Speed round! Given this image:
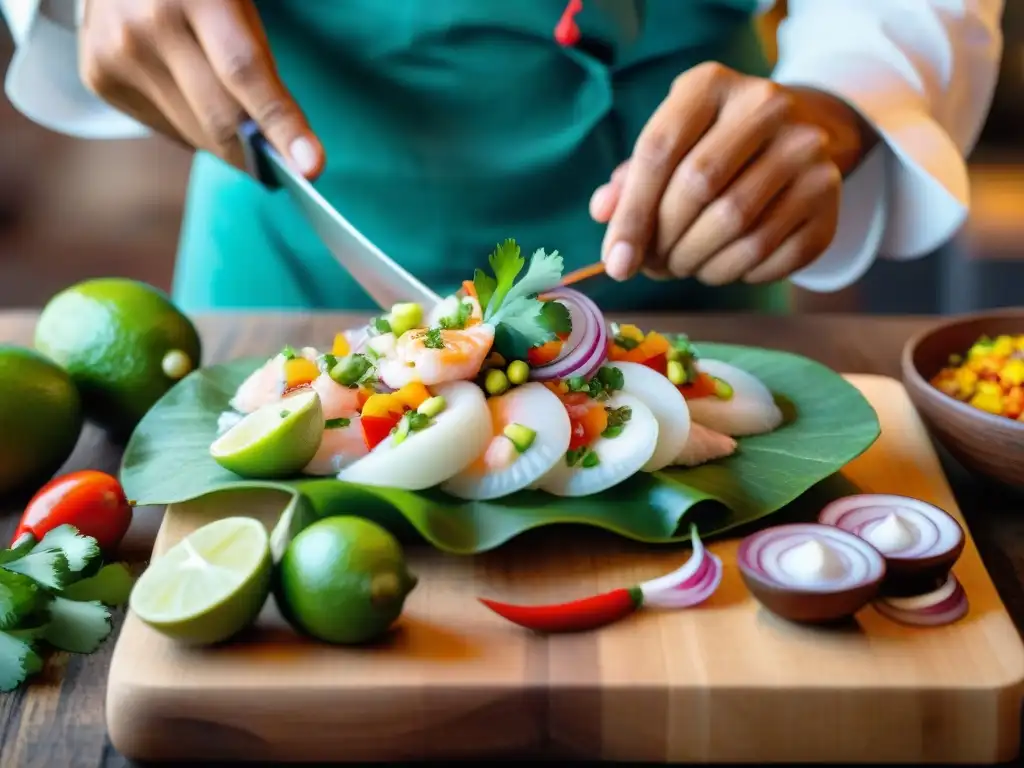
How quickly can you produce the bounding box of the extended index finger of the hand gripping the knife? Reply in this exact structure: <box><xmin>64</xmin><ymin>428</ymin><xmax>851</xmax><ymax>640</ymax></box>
<box><xmin>188</xmin><ymin>0</ymin><xmax>325</xmax><ymax>177</ymax></box>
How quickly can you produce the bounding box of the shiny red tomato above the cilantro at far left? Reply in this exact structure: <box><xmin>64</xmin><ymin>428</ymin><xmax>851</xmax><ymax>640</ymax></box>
<box><xmin>11</xmin><ymin>470</ymin><xmax>132</xmax><ymax>555</ymax></box>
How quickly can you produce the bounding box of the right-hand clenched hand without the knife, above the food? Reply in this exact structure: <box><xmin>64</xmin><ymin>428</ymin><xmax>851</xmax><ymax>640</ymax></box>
<box><xmin>591</xmin><ymin>63</ymin><xmax>874</xmax><ymax>286</ymax></box>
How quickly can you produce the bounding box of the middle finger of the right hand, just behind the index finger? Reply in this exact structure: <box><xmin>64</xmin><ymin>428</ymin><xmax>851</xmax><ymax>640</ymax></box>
<box><xmin>654</xmin><ymin>80</ymin><xmax>792</xmax><ymax>278</ymax></box>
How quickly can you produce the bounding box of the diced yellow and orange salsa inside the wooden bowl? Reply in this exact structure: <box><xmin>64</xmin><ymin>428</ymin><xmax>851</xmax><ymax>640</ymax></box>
<box><xmin>932</xmin><ymin>334</ymin><xmax>1024</xmax><ymax>422</ymax></box>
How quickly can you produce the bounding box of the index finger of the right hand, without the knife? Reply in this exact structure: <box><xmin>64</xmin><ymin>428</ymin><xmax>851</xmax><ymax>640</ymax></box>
<box><xmin>601</xmin><ymin>65</ymin><xmax>724</xmax><ymax>280</ymax></box>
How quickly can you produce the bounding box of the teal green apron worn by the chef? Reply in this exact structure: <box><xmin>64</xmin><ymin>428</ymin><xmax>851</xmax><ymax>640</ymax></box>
<box><xmin>174</xmin><ymin>0</ymin><xmax>787</xmax><ymax>312</ymax></box>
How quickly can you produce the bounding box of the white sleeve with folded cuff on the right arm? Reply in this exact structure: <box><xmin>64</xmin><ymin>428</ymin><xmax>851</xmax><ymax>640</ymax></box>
<box><xmin>761</xmin><ymin>0</ymin><xmax>1004</xmax><ymax>292</ymax></box>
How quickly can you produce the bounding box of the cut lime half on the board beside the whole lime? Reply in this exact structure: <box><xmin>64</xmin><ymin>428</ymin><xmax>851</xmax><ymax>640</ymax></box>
<box><xmin>129</xmin><ymin>517</ymin><xmax>272</xmax><ymax>645</ymax></box>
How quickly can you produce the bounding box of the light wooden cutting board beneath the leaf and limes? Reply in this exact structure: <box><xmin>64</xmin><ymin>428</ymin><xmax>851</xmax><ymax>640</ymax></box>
<box><xmin>106</xmin><ymin>376</ymin><xmax>1024</xmax><ymax>764</ymax></box>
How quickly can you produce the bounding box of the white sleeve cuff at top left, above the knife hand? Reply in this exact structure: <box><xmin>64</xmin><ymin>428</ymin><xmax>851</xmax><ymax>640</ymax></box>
<box><xmin>0</xmin><ymin>0</ymin><xmax>150</xmax><ymax>138</ymax></box>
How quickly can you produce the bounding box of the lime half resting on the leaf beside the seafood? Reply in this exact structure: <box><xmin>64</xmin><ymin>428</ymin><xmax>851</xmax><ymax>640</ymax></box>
<box><xmin>210</xmin><ymin>389</ymin><xmax>324</xmax><ymax>478</ymax></box>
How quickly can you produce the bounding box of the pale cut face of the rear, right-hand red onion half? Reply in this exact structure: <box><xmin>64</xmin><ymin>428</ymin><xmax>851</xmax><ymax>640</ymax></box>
<box><xmin>818</xmin><ymin>494</ymin><xmax>964</xmax><ymax>564</ymax></box>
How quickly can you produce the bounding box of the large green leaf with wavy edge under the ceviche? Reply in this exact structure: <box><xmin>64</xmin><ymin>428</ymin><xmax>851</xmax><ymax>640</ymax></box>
<box><xmin>121</xmin><ymin>343</ymin><xmax>880</xmax><ymax>554</ymax></box>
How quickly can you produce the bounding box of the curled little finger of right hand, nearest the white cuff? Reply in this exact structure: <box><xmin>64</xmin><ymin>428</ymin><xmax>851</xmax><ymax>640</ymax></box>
<box><xmin>696</xmin><ymin>162</ymin><xmax>842</xmax><ymax>285</ymax></box>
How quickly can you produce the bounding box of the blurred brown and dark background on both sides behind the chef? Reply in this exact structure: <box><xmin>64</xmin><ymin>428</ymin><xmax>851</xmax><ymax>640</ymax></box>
<box><xmin>0</xmin><ymin>5</ymin><xmax>1024</xmax><ymax>313</ymax></box>
